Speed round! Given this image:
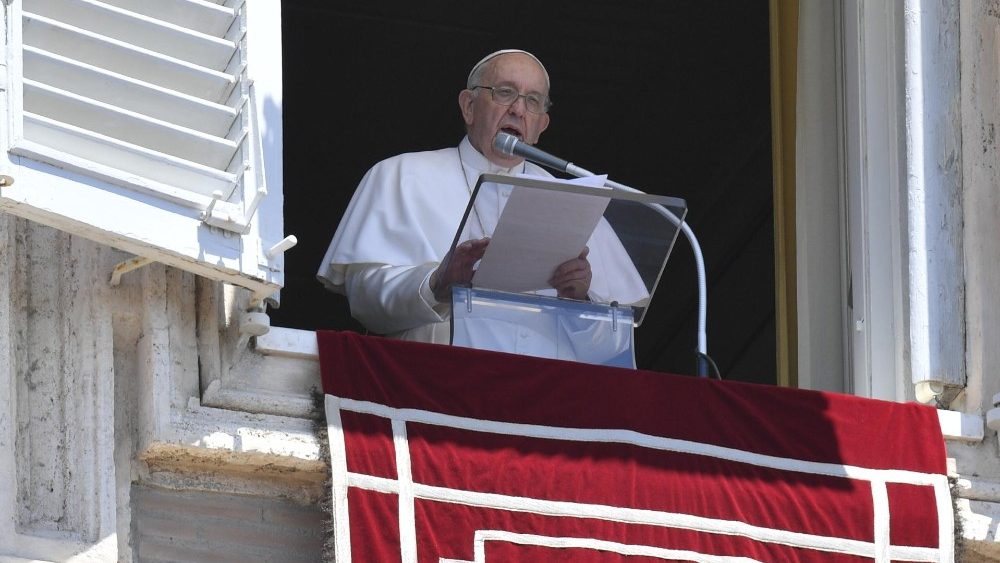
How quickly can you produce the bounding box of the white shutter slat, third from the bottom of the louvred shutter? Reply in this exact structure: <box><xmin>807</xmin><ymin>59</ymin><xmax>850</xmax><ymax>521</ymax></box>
<box><xmin>24</xmin><ymin>46</ymin><xmax>238</xmax><ymax>137</ymax></box>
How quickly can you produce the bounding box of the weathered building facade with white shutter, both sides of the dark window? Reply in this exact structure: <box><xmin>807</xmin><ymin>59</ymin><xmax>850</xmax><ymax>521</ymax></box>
<box><xmin>0</xmin><ymin>0</ymin><xmax>1000</xmax><ymax>561</ymax></box>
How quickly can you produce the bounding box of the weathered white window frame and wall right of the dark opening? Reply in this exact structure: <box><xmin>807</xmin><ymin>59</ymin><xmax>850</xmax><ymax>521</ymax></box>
<box><xmin>797</xmin><ymin>0</ymin><xmax>1000</xmax><ymax>561</ymax></box>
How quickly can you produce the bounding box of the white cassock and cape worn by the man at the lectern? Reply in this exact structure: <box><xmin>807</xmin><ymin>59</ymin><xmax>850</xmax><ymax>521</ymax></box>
<box><xmin>317</xmin><ymin>138</ymin><xmax>648</xmax><ymax>354</ymax></box>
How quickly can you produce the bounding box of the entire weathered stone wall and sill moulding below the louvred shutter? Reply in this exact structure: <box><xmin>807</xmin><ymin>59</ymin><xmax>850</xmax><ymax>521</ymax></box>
<box><xmin>0</xmin><ymin>214</ymin><xmax>326</xmax><ymax>561</ymax></box>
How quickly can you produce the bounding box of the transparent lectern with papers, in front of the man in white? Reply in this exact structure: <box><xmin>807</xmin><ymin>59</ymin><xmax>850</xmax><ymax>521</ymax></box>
<box><xmin>442</xmin><ymin>174</ymin><xmax>687</xmax><ymax>368</ymax></box>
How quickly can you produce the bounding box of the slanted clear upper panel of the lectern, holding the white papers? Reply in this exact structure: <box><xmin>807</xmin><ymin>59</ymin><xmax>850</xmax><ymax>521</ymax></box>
<box><xmin>451</xmin><ymin>174</ymin><xmax>687</xmax><ymax>326</ymax></box>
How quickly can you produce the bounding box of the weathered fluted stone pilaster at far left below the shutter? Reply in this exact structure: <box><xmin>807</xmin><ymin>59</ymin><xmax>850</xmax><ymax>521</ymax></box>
<box><xmin>0</xmin><ymin>215</ymin><xmax>115</xmax><ymax>559</ymax></box>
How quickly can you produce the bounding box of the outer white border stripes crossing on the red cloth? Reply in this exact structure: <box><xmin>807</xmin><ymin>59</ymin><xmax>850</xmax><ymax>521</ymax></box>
<box><xmin>327</xmin><ymin>396</ymin><xmax>954</xmax><ymax>563</ymax></box>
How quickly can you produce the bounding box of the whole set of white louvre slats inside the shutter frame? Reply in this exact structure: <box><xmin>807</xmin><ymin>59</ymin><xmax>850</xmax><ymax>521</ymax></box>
<box><xmin>19</xmin><ymin>0</ymin><xmax>258</xmax><ymax>212</ymax></box>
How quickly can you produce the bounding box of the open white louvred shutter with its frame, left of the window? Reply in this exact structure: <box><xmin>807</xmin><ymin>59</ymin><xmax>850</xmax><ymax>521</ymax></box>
<box><xmin>0</xmin><ymin>0</ymin><xmax>283</xmax><ymax>295</ymax></box>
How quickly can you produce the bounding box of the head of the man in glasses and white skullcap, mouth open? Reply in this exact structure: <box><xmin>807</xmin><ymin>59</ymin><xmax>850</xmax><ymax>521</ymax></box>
<box><xmin>458</xmin><ymin>53</ymin><xmax>549</xmax><ymax>167</ymax></box>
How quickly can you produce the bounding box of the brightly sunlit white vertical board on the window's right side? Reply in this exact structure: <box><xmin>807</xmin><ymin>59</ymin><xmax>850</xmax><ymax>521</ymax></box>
<box><xmin>903</xmin><ymin>0</ymin><xmax>964</xmax><ymax>402</ymax></box>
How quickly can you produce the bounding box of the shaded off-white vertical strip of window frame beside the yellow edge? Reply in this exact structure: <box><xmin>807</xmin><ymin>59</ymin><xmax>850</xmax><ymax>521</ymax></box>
<box><xmin>795</xmin><ymin>0</ymin><xmax>849</xmax><ymax>392</ymax></box>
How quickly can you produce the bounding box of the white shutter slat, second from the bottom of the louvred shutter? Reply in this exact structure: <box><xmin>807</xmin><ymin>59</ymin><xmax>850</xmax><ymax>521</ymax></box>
<box><xmin>24</xmin><ymin>80</ymin><xmax>239</xmax><ymax>170</ymax></box>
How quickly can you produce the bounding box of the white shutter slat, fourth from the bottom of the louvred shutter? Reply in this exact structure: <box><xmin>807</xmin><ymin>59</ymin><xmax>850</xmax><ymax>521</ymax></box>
<box><xmin>22</xmin><ymin>12</ymin><xmax>236</xmax><ymax>102</ymax></box>
